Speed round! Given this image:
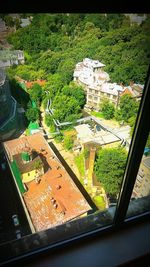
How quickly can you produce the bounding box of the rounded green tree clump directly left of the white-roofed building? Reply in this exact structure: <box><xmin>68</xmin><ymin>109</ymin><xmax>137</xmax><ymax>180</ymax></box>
<box><xmin>43</xmin><ymin>82</ymin><xmax>85</xmax><ymax>125</ymax></box>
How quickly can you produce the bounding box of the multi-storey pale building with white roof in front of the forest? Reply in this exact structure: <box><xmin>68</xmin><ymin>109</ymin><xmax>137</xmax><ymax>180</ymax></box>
<box><xmin>73</xmin><ymin>58</ymin><xmax>124</xmax><ymax>111</ymax></box>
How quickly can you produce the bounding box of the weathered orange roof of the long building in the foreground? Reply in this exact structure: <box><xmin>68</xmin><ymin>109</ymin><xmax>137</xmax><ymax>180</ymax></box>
<box><xmin>4</xmin><ymin>133</ymin><xmax>91</xmax><ymax>231</ymax></box>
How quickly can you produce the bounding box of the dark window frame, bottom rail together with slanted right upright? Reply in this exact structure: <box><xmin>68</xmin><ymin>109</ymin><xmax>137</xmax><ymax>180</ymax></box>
<box><xmin>0</xmin><ymin>68</ymin><xmax>150</xmax><ymax>265</ymax></box>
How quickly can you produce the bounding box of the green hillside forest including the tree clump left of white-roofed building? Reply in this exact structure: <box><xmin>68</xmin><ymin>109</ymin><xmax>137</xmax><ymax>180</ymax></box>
<box><xmin>3</xmin><ymin>13</ymin><xmax>150</xmax><ymax>127</ymax></box>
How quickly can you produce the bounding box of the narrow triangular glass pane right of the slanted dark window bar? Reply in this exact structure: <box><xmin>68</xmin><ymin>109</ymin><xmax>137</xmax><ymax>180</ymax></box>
<box><xmin>127</xmin><ymin>134</ymin><xmax>150</xmax><ymax>217</ymax></box>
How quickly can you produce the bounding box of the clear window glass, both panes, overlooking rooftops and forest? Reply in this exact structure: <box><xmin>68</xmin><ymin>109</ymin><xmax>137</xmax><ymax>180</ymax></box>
<box><xmin>0</xmin><ymin>13</ymin><xmax>150</xmax><ymax>266</ymax></box>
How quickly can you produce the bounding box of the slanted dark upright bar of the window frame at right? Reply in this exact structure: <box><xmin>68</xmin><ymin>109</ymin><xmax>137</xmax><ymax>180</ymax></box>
<box><xmin>113</xmin><ymin>67</ymin><xmax>150</xmax><ymax>225</ymax></box>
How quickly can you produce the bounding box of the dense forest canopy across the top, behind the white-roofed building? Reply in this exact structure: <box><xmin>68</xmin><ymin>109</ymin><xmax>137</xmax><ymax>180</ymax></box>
<box><xmin>8</xmin><ymin>13</ymin><xmax>150</xmax><ymax>84</ymax></box>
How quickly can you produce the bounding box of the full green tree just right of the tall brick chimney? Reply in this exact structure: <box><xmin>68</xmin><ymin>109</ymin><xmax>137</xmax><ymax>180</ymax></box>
<box><xmin>94</xmin><ymin>147</ymin><xmax>127</xmax><ymax>197</ymax></box>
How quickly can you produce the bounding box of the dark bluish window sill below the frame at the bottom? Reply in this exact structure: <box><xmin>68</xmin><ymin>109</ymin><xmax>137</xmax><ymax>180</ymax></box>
<box><xmin>3</xmin><ymin>219</ymin><xmax>150</xmax><ymax>267</ymax></box>
